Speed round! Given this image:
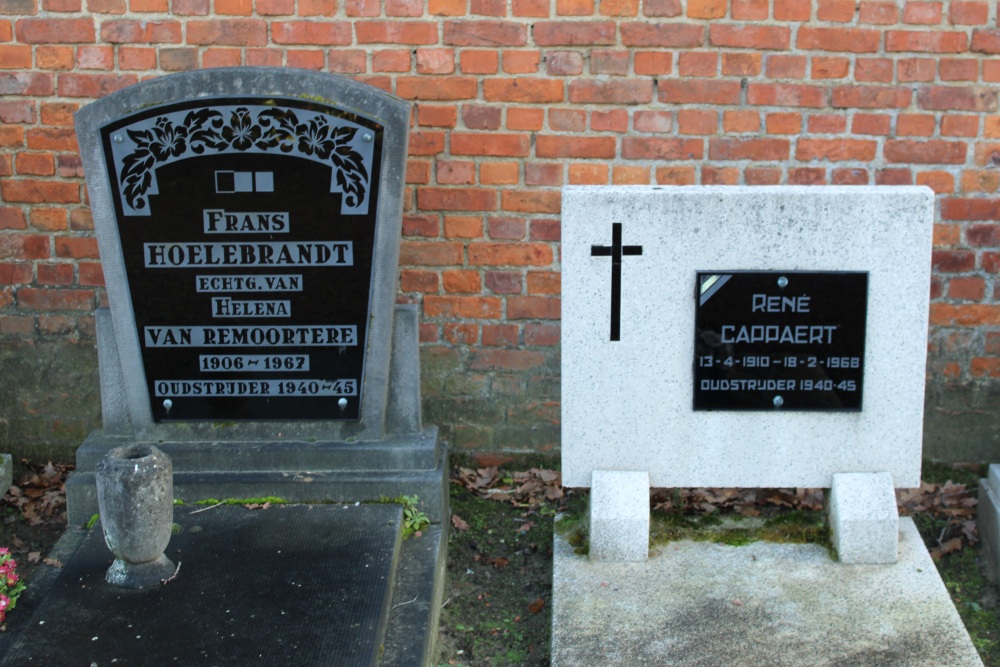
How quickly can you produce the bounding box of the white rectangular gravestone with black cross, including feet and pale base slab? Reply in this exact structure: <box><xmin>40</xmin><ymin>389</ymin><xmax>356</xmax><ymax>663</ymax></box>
<box><xmin>553</xmin><ymin>187</ymin><xmax>978</xmax><ymax>665</ymax></box>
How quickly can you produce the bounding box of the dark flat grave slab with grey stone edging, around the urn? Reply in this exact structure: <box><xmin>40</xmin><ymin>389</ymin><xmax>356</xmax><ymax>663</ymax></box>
<box><xmin>0</xmin><ymin>504</ymin><xmax>446</xmax><ymax>667</ymax></box>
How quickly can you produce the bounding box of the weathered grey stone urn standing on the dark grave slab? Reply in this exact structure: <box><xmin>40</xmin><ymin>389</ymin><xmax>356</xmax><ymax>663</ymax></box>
<box><xmin>97</xmin><ymin>444</ymin><xmax>175</xmax><ymax>588</ymax></box>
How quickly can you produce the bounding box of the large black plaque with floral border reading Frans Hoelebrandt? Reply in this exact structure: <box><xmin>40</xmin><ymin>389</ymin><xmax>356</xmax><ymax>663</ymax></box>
<box><xmin>101</xmin><ymin>97</ymin><xmax>383</xmax><ymax>421</ymax></box>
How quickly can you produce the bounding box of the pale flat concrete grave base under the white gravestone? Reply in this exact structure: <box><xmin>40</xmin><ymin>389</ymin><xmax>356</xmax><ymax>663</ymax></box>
<box><xmin>552</xmin><ymin>518</ymin><xmax>982</xmax><ymax>667</ymax></box>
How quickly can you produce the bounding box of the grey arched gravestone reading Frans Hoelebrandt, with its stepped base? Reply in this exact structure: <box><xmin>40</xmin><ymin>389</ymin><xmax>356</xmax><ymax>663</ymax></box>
<box><xmin>8</xmin><ymin>68</ymin><xmax>448</xmax><ymax>664</ymax></box>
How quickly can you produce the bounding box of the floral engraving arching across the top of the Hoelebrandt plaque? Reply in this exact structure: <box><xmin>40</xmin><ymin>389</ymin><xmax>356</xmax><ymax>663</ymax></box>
<box><xmin>120</xmin><ymin>107</ymin><xmax>368</xmax><ymax>210</ymax></box>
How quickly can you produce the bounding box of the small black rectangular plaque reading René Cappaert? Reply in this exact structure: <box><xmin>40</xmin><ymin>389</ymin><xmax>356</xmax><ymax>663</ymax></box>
<box><xmin>694</xmin><ymin>271</ymin><xmax>868</xmax><ymax>411</ymax></box>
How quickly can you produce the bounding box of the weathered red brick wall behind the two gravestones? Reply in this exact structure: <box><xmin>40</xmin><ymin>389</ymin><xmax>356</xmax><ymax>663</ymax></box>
<box><xmin>0</xmin><ymin>0</ymin><xmax>1000</xmax><ymax>459</ymax></box>
